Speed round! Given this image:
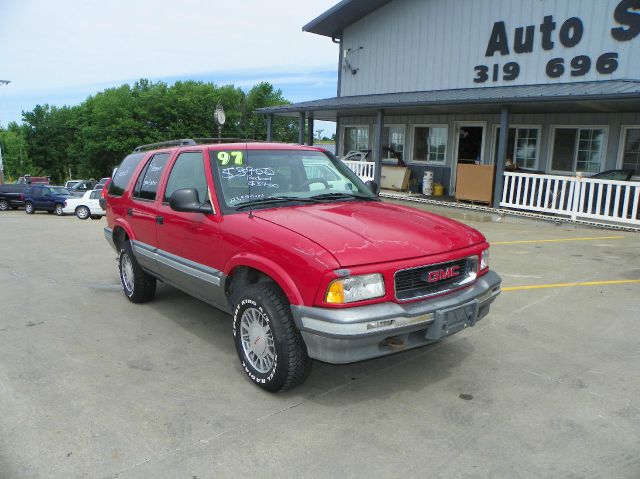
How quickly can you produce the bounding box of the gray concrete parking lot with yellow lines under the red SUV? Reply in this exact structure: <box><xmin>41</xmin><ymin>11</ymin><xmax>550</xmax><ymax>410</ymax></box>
<box><xmin>0</xmin><ymin>208</ymin><xmax>640</xmax><ymax>479</ymax></box>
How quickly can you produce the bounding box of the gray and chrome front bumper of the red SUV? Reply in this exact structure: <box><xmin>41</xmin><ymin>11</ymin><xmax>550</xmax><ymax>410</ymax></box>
<box><xmin>291</xmin><ymin>271</ymin><xmax>502</xmax><ymax>364</ymax></box>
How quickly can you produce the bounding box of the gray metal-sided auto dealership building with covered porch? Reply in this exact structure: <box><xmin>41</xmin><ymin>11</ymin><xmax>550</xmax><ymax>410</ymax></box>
<box><xmin>261</xmin><ymin>0</ymin><xmax>640</xmax><ymax>205</ymax></box>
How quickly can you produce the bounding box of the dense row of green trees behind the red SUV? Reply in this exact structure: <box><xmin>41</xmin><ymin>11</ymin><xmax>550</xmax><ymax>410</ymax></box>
<box><xmin>20</xmin><ymin>79</ymin><xmax>298</xmax><ymax>182</ymax></box>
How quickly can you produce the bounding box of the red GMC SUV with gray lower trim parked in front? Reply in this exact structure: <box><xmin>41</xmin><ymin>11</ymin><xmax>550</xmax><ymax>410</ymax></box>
<box><xmin>105</xmin><ymin>140</ymin><xmax>500</xmax><ymax>391</ymax></box>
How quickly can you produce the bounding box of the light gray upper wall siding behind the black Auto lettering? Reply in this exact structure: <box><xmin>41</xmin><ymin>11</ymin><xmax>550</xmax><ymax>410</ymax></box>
<box><xmin>340</xmin><ymin>0</ymin><xmax>640</xmax><ymax>96</ymax></box>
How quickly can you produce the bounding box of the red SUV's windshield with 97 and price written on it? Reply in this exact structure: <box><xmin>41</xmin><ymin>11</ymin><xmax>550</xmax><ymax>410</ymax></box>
<box><xmin>210</xmin><ymin>150</ymin><xmax>375</xmax><ymax>210</ymax></box>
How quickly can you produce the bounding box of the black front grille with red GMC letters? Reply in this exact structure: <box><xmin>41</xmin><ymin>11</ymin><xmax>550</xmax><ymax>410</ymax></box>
<box><xmin>395</xmin><ymin>256</ymin><xmax>478</xmax><ymax>301</ymax></box>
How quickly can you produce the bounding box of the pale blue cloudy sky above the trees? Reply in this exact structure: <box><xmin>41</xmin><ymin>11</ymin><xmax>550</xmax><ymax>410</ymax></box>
<box><xmin>0</xmin><ymin>0</ymin><xmax>338</xmax><ymax>134</ymax></box>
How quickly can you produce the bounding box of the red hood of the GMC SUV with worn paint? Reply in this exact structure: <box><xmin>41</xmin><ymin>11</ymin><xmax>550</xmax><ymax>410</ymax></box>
<box><xmin>253</xmin><ymin>201</ymin><xmax>485</xmax><ymax>267</ymax></box>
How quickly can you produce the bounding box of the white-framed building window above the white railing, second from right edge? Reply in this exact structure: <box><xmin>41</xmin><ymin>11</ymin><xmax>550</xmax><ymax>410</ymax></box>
<box><xmin>551</xmin><ymin>128</ymin><xmax>605</xmax><ymax>173</ymax></box>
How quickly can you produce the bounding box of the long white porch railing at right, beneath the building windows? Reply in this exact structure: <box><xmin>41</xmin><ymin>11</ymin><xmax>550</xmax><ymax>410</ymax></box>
<box><xmin>500</xmin><ymin>172</ymin><xmax>640</xmax><ymax>225</ymax></box>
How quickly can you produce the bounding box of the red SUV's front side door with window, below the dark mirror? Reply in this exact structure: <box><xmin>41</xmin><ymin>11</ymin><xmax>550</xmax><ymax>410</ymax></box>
<box><xmin>156</xmin><ymin>151</ymin><xmax>227</xmax><ymax>309</ymax></box>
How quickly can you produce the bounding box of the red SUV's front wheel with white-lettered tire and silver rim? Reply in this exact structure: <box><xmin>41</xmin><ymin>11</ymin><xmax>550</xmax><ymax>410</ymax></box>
<box><xmin>233</xmin><ymin>283</ymin><xmax>311</xmax><ymax>392</ymax></box>
